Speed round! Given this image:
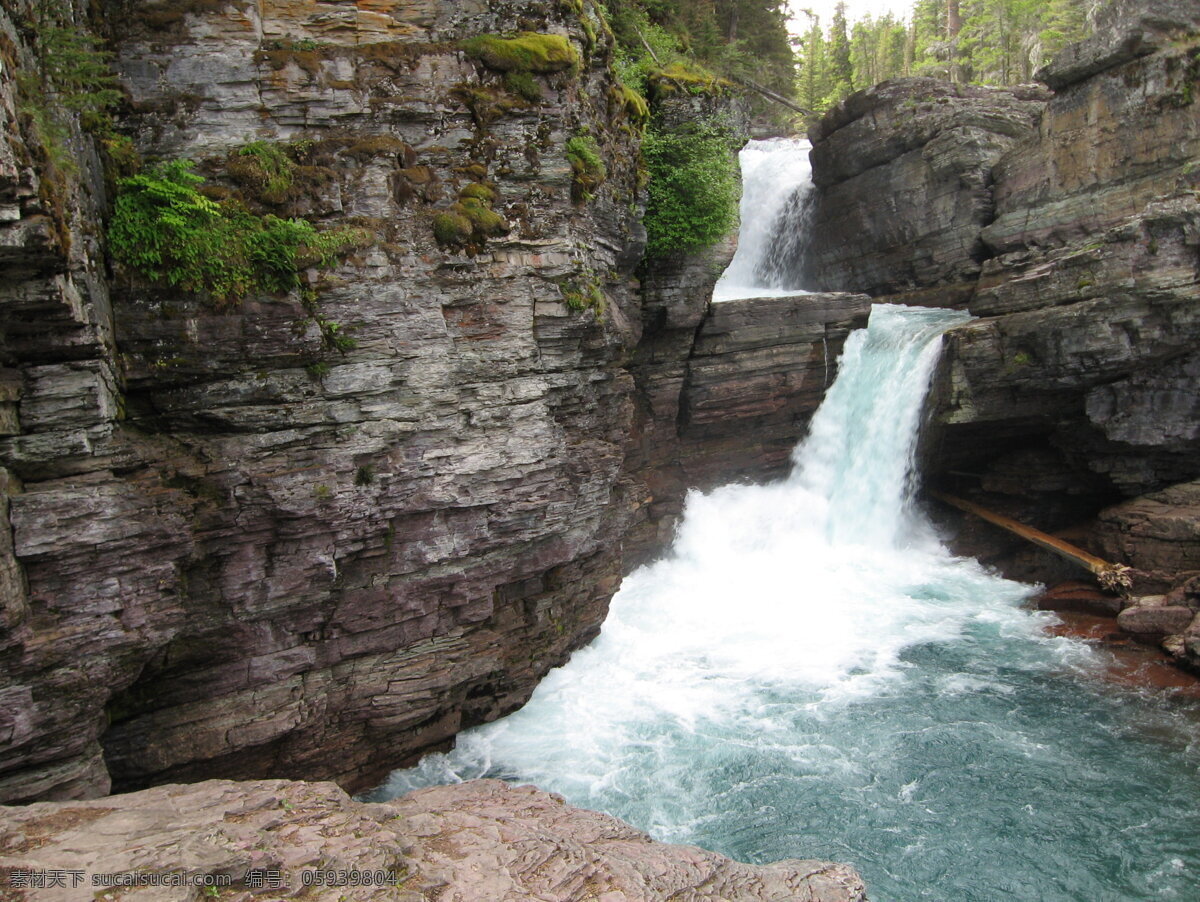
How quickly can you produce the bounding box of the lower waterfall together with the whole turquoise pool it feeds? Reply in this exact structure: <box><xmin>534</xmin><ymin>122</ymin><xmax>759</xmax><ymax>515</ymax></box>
<box><xmin>374</xmin><ymin>306</ymin><xmax>1200</xmax><ymax>902</ymax></box>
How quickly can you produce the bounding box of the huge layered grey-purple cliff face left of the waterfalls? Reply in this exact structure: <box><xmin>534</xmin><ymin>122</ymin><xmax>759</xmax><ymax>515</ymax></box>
<box><xmin>0</xmin><ymin>1</ymin><xmax>657</xmax><ymax>800</ymax></box>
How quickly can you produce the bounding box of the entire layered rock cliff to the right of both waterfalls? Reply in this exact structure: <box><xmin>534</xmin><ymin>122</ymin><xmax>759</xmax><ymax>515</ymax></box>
<box><xmin>803</xmin><ymin>2</ymin><xmax>1200</xmax><ymax>666</ymax></box>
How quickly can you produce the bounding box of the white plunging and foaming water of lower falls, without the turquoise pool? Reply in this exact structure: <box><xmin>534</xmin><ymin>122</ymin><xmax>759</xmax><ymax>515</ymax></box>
<box><xmin>374</xmin><ymin>306</ymin><xmax>1037</xmax><ymax>801</ymax></box>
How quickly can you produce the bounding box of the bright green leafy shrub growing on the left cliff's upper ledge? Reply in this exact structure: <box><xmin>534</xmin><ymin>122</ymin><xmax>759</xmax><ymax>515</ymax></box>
<box><xmin>108</xmin><ymin>160</ymin><xmax>371</xmax><ymax>301</ymax></box>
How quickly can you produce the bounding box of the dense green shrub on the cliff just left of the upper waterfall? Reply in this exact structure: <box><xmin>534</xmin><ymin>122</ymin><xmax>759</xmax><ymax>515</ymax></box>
<box><xmin>642</xmin><ymin>122</ymin><xmax>740</xmax><ymax>257</ymax></box>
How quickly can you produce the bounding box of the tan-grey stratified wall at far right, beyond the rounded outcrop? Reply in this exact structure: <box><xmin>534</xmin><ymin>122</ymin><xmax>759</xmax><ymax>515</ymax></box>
<box><xmin>944</xmin><ymin>4</ymin><xmax>1200</xmax><ymax>495</ymax></box>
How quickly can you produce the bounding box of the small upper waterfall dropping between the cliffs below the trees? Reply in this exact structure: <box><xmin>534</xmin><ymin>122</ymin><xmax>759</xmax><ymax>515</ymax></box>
<box><xmin>713</xmin><ymin>138</ymin><xmax>812</xmax><ymax>301</ymax></box>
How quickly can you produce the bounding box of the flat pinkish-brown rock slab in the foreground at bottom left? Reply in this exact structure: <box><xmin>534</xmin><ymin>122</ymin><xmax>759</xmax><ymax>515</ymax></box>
<box><xmin>0</xmin><ymin>780</ymin><xmax>866</xmax><ymax>902</ymax></box>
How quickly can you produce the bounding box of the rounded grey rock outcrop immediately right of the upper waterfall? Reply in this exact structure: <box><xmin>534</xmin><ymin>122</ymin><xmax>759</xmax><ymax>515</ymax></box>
<box><xmin>797</xmin><ymin>78</ymin><xmax>1049</xmax><ymax>295</ymax></box>
